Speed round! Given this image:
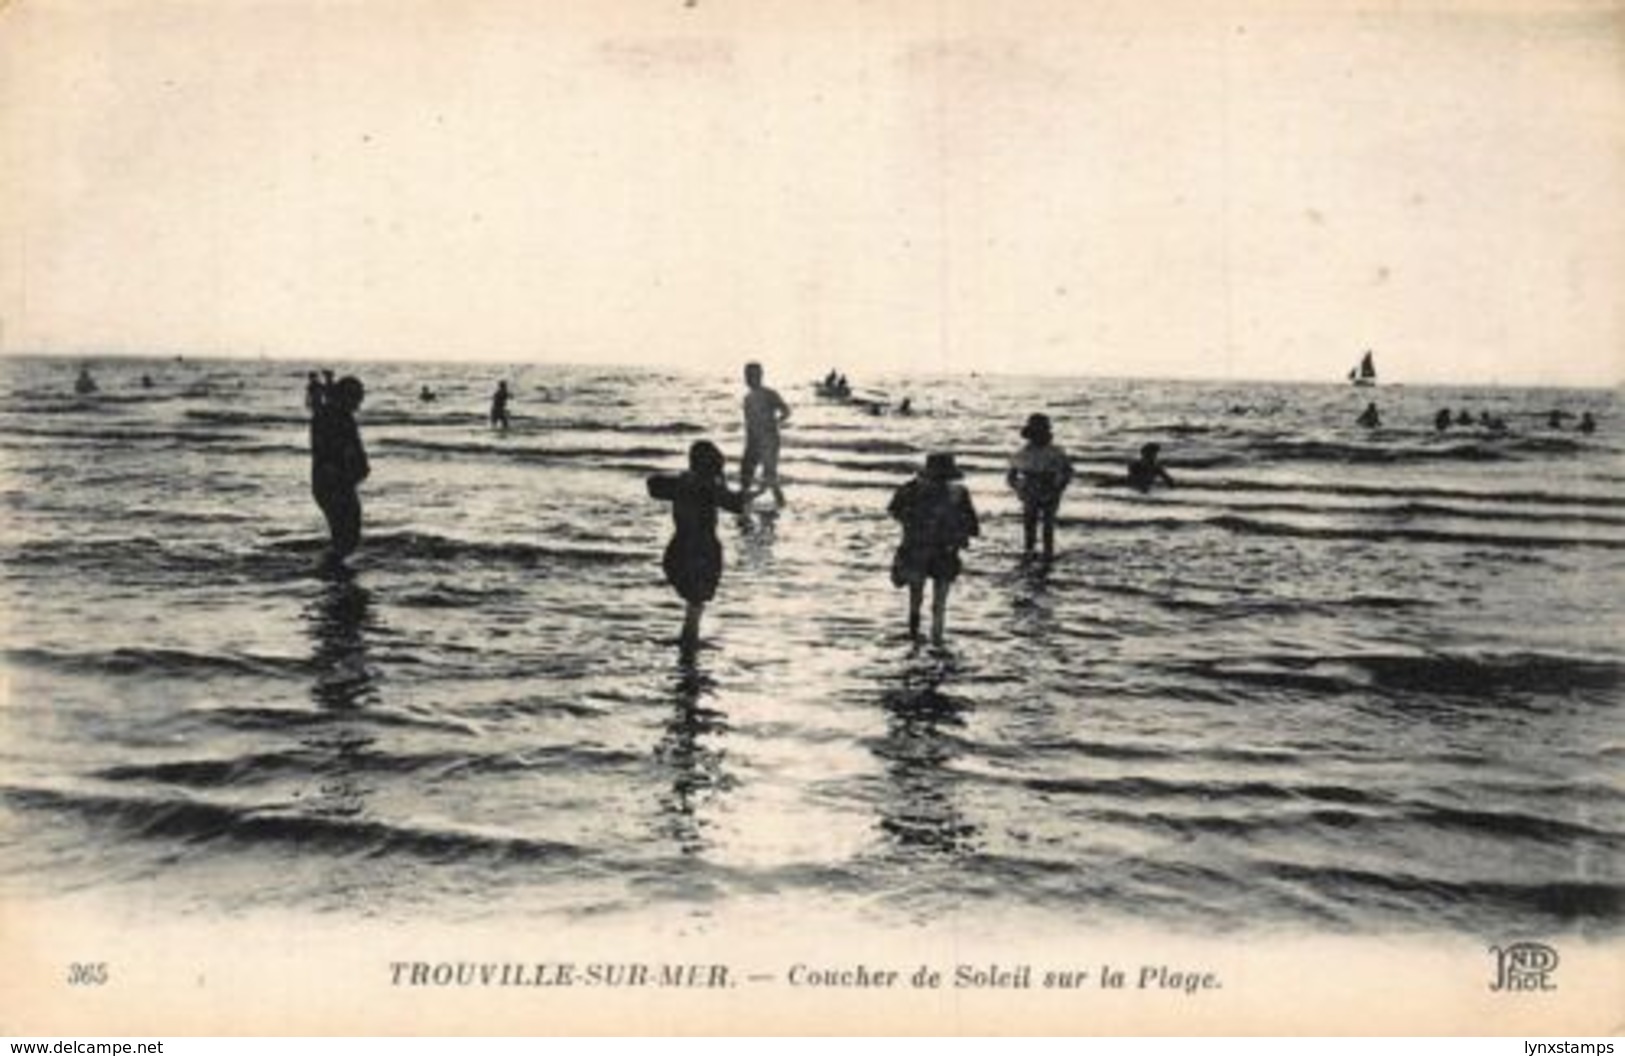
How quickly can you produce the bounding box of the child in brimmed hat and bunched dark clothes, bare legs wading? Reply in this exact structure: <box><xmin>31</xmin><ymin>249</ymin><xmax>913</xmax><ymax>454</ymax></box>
<box><xmin>887</xmin><ymin>453</ymin><xmax>982</xmax><ymax>645</ymax></box>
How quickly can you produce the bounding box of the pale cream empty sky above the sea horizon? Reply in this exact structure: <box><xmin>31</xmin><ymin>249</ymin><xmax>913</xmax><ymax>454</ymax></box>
<box><xmin>0</xmin><ymin>0</ymin><xmax>1625</xmax><ymax>385</ymax></box>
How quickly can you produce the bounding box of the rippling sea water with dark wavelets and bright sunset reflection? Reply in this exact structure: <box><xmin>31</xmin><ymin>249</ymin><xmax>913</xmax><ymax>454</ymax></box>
<box><xmin>0</xmin><ymin>359</ymin><xmax>1625</xmax><ymax>934</ymax></box>
